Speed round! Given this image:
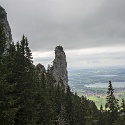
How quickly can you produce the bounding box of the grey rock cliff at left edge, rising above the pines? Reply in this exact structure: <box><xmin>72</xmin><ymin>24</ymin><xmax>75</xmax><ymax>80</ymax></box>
<box><xmin>0</xmin><ymin>6</ymin><xmax>12</xmax><ymax>53</ymax></box>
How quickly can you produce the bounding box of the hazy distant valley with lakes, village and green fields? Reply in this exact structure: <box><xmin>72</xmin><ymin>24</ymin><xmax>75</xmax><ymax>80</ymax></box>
<box><xmin>68</xmin><ymin>68</ymin><xmax>125</xmax><ymax>108</ymax></box>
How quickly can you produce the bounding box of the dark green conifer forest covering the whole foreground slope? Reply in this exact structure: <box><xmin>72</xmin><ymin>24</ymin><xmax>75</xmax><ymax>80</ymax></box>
<box><xmin>0</xmin><ymin>23</ymin><xmax>125</xmax><ymax>125</ymax></box>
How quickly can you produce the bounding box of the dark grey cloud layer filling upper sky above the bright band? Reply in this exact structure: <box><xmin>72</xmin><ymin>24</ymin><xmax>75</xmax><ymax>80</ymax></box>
<box><xmin>2</xmin><ymin>0</ymin><xmax>125</xmax><ymax>51</ymax></box>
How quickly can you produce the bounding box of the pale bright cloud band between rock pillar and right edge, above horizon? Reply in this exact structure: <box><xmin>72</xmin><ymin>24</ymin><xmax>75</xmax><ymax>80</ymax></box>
<box><xmin>67</xmin><ymin>52</ymin><xmax>125</xmax><ymax>67</ymax></box>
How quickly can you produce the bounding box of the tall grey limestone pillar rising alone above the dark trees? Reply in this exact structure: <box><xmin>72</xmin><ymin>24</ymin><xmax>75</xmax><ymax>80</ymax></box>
<box><xmin>53</xmin><ymin>46</ymin><xmax>68</xmax><ymax>87</ymax></box>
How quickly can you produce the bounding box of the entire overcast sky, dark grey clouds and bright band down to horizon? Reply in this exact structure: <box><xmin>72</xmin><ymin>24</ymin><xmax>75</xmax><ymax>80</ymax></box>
<box><xmin>0</xmin><ymin>0</ymin><xmax>125</xmax><ymax>68</ymax></box>
